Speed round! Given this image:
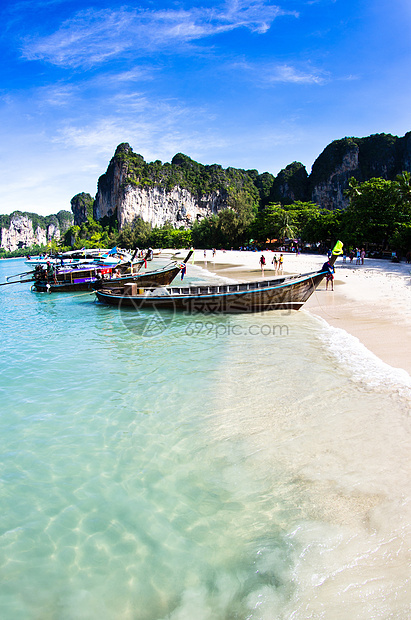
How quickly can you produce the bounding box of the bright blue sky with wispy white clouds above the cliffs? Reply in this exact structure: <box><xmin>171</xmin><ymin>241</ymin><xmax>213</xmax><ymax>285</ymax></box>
<box><xmin>0</xmin><ymin>0</ymin><xmax>411</xmax><ymax>215</ymax></box>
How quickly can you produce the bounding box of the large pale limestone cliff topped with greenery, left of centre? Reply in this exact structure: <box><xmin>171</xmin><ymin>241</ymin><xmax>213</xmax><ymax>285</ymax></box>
<box><xmin>94</xmin><ymin>144</ymin><xmax>258</xmax><ymax>228</ymax></box>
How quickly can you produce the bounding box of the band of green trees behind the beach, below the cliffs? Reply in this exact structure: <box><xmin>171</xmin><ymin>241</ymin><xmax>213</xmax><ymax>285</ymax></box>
<box><xmin>4</xmin><ymin>172</ymin><xmax>411</xmax><ymax>256</ymax></box>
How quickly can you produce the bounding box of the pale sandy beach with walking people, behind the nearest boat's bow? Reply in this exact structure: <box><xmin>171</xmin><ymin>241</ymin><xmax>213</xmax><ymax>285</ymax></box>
<box><xmin>187</xmin><ymin>250</ymin><xmax>411</xmax><ymax>374</ymax></box>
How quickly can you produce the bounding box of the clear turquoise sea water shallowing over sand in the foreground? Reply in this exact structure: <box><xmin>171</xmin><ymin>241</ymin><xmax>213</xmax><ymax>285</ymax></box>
<box><xmin>0</xmin><ymin>260</ymin><xmax>411</xmax><ymax>620</ymax></box>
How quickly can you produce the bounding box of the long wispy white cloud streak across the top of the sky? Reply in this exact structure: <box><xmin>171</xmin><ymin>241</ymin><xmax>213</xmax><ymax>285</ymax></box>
<box><xmin>22</xmin><ymin>0</ymin><xmax>296</xmax><ymax>67</ymax></box>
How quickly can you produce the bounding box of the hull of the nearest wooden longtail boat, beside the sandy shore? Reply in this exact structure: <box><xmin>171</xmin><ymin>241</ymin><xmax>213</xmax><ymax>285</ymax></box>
<box><xmin>96</xmin><ymin>272</ymin><xmax>325</xmax><ymax>314</ymax></box>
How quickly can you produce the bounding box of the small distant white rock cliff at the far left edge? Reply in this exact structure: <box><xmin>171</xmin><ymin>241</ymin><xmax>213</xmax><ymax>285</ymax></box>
<box><xmin>0</xmin><ymin>211</ymin><xmax>73</xmax><ymax>252</ymax></box>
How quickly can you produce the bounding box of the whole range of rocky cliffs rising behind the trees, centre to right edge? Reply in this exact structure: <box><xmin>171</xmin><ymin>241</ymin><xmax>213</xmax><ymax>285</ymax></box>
<box><xmin>72</xmin><ymin>132</ymin><xmax>411</xmax><ymax>228</ymax></box>
